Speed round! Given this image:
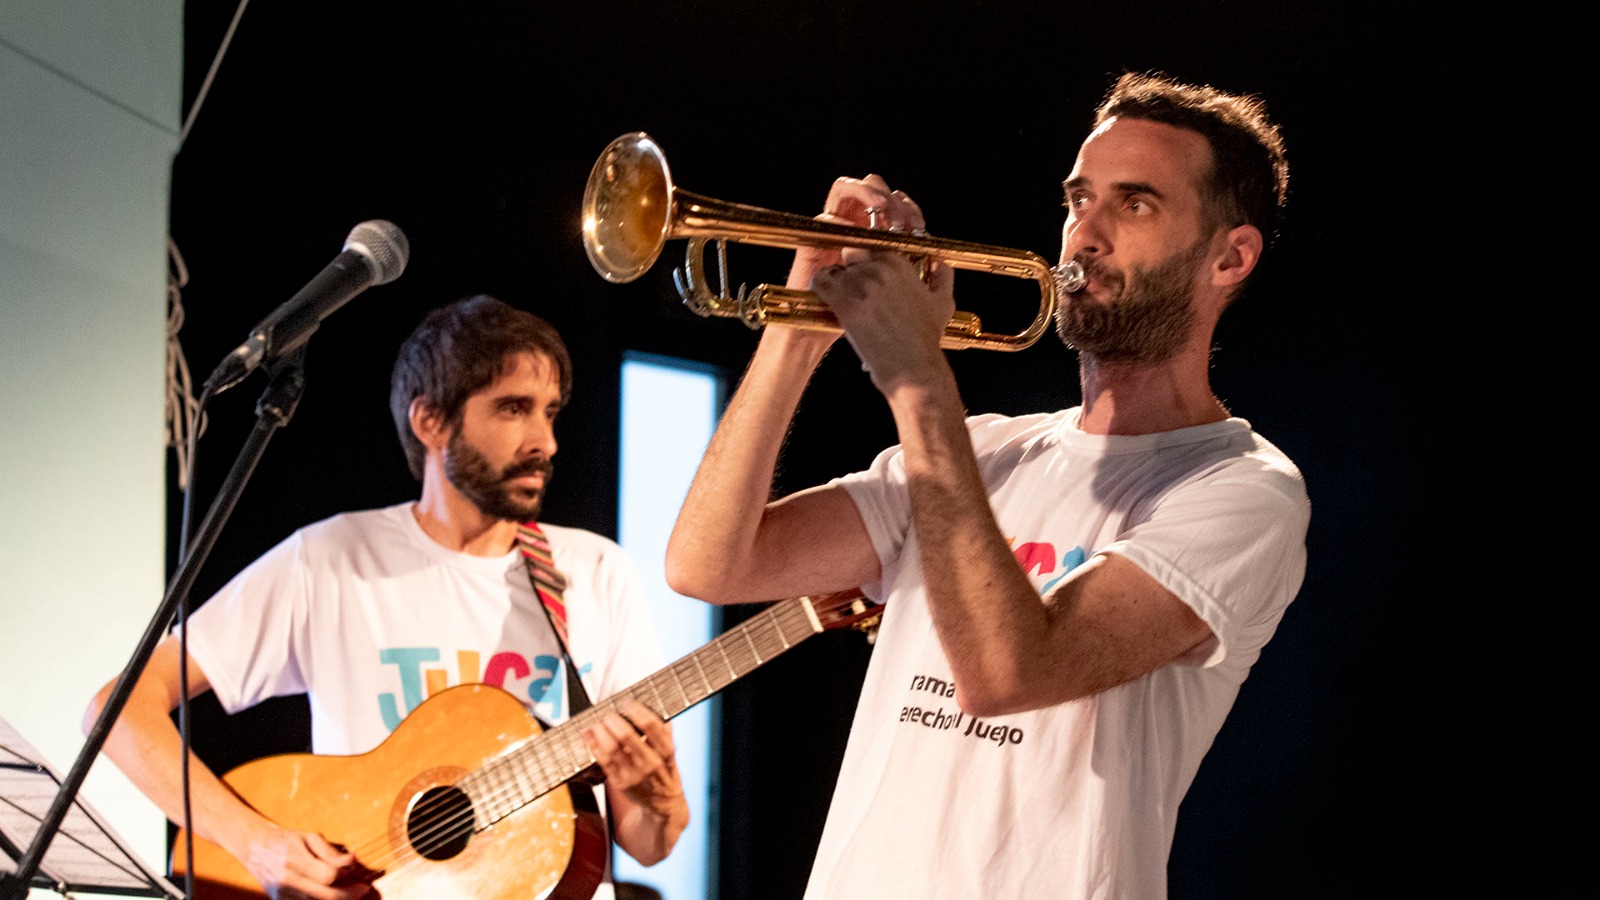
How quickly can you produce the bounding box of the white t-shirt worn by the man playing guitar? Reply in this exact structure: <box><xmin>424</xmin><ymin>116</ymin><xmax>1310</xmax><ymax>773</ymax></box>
<box><xmin>189</xmin><ymin>503</ymin><xmax>661</xmax><ymax>895</ymax></box>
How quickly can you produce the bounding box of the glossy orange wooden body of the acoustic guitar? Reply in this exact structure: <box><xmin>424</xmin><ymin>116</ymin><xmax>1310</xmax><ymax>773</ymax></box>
<box><xmin>173</xmin><ymin>684</ymin><xmax>610</xmax><ymax>900</ymax></box>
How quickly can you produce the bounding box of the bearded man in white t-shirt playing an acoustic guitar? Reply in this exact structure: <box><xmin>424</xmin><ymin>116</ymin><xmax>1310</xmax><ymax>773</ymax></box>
<box><xmin>85</xmin><ymin>295</ymin><xmax>690</xmax><ymax>900</ymax></box>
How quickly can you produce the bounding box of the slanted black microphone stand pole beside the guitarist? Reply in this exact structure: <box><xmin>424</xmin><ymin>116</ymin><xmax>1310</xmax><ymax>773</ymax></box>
<box><xmin>0</xmin><ymin>346</ymin><xmax>306</xmax><ymax>900</ymax></box>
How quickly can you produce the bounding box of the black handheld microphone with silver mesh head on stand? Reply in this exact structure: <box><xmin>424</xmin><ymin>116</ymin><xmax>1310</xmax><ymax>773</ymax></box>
<box><xmin>205</xmin><ymin>219</ymin><xmax>411</xmax><ymax>394</ymax></box>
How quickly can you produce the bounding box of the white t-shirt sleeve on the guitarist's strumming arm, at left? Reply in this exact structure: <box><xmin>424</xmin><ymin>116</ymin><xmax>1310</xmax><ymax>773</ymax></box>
<box><xmin>189</xmin><ymin>533</ymin><xmax>307</xmax><ymax>713</ymax></box>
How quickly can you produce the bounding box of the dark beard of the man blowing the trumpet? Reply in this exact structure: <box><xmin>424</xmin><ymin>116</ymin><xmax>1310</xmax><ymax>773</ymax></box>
<box><xmin>1056</xmin><ymin>239</ymin><xmax>1208</xmax><ymax>365</ymax></box>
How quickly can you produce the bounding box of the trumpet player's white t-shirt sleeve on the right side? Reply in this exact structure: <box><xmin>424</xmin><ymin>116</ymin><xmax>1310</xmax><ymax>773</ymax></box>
<box><xmin>1099</xmin><ymin>458</ymin><xmax>1310</xmax><ymax>666</ymax></box>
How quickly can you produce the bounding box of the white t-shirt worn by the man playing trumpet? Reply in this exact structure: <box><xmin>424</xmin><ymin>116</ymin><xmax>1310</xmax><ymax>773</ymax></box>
<box><xmin>806</xmin><ymin>408</ymin><xmax>1310</xmax><ymax>900</ymax></box>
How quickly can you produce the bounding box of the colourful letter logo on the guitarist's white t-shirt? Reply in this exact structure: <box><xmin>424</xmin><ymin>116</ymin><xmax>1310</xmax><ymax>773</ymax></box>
<box><xmin>378</xmin><ymin>647</ymin><xmax>592</xmax><ymax>732</ymax></box>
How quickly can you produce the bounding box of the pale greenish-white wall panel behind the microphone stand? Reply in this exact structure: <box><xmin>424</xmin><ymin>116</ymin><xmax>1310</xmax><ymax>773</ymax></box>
<box><xmin>0</xmin><ymin>0</ymin><xmax>182</xmax><ymax>897</ymax></box>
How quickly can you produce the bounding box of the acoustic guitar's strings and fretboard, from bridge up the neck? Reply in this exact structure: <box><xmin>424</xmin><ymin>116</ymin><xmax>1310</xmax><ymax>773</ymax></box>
<box><xmin>329</xmin><ymin>602</ymin><xmax>816</xmax><ymax>873</ymax></box>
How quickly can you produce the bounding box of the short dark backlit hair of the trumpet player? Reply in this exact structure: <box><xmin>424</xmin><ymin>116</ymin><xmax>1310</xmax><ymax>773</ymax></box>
<box><xmin>1094</xmin><ymin>72</ymin><xmax>1290</xmax><ymax>242</ymax></box>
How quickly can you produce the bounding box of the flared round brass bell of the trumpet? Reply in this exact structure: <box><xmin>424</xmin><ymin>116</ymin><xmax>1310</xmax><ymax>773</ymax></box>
<box><xmin>582</xmin><ymin>131</ymin><xmax>672</xmax><ymax>283</ymax></box>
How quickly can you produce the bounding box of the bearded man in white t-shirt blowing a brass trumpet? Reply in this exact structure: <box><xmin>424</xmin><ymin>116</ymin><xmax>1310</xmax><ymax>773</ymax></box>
<box><xmin>667</xmin><ymin>75</ymin><xmax>1310</xmax><ymax>900</ymax></box>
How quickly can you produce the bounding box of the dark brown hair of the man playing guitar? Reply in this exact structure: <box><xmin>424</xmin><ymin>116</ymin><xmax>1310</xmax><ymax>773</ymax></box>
<box><xmin>389</xmin><ymin>293</ymin><xmax>573</xmax><ymax>480</ymax></box>
